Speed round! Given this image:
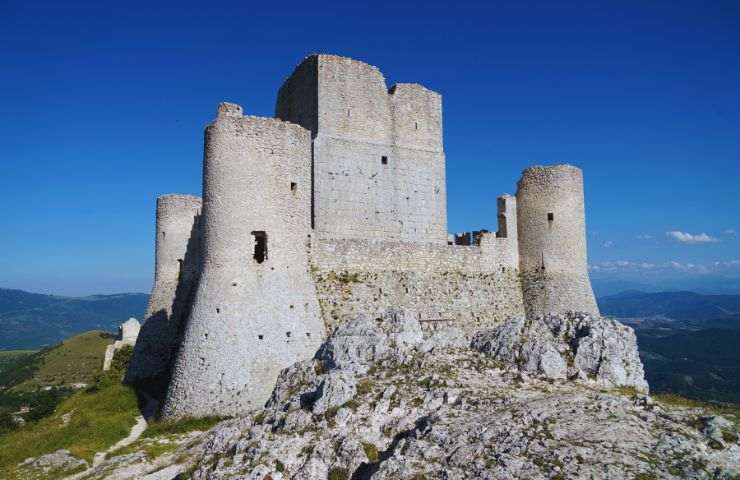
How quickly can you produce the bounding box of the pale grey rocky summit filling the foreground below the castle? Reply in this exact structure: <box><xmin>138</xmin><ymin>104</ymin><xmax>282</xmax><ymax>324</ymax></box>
<box><xmin>49</xmin><ymin>310</ymin><xmax>740</xmax><ymax>480</ymax></box>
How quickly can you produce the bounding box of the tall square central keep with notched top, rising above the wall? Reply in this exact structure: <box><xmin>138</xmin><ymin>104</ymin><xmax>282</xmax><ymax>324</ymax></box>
<box><xmin>275</xmin><ymin>54</ymin><xmax>447</xmax><ymax>245</ymax></box>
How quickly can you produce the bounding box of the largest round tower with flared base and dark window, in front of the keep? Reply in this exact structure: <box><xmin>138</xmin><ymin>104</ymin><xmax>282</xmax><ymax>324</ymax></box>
<box><xmin>162</xmin><ymin>103</ymin><xmax>323</xmax><ymax>418</ymax></box>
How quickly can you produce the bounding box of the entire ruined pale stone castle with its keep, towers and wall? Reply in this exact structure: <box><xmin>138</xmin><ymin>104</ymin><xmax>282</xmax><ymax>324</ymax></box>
<box><xmin>127</xmin><ymin>55</ymin><xmax>598</xmax><ymax>418</ymax></box>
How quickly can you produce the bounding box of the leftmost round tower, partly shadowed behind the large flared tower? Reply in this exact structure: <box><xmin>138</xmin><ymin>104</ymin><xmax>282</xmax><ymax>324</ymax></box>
<box><xmin>126</xmin><ymin>194</ymin><xmax>201</xmax><ymax>398</ymax></box>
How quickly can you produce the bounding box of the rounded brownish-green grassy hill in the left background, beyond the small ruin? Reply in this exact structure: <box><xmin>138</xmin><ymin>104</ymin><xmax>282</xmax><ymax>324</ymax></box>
<box><xmin>14</xmin><ymin>331</ymin><xmax>113</xmax><ymax>391</ymax></box>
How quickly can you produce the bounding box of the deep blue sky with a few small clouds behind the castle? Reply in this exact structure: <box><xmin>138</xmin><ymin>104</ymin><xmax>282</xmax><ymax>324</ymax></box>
<box><xmin>0</xmin><ymin>0</ymin><xmax>740</xmax><ymax>295</ymax></box>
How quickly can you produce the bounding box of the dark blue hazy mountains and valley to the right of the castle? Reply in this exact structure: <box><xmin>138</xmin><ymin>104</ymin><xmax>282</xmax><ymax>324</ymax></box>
<box><xmin>599</xmin><ymin>291</ymin><xmax>740</xmax><ymax>404</ymax></box>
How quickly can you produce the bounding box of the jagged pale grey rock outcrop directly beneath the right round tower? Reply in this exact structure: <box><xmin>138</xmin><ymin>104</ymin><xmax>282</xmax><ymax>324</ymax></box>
<box><xmin>472</xmin><ymin>312</ymin><xmax>648</xmax><ymax>393</ymax></box>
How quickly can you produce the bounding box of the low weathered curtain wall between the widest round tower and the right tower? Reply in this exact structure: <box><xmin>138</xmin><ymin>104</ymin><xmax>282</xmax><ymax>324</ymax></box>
<box><xmin>310</xmin><ymin>239</ymin><xmax>524</xmax><ymax>331</ymax></box>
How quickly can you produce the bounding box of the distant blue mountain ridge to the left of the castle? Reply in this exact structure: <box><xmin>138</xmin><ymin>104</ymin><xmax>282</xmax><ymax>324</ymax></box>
<box><xmin>0</xmin><ymin>289</ymin><xmax>149</xmax><ymax>351</ymax></box>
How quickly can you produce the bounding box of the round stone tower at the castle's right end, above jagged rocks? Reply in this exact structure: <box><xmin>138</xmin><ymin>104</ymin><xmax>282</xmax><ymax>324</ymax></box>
<box><xmin>516</xmin><ymin>165</ymin><xmax>598</xmax><ymax>316</ymax></box>
